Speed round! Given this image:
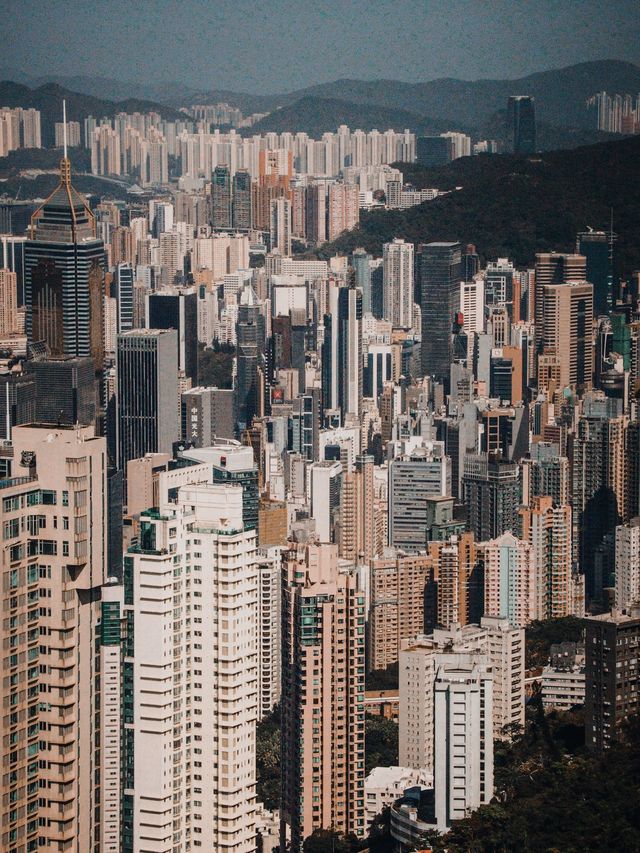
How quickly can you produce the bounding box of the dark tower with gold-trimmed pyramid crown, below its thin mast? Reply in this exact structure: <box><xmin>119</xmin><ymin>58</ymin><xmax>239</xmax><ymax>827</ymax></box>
<box><xmin>24</xmin><ymin>156</ymin><xmax>105</xmax><ymax>362</ymax></box>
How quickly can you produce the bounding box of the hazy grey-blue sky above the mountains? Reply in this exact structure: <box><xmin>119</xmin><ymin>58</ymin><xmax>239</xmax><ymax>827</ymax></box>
<box><xmin>5</xmin><ymin>0</ymin><xmax>640</xmax><ymax>94</ymax></box>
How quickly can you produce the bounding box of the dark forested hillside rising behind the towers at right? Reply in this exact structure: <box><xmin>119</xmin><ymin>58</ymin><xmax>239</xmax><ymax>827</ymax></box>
<box><xmin>316</xmin><ymin>136</ymin><xmax>640</xmax><ymax>275</ymax></box>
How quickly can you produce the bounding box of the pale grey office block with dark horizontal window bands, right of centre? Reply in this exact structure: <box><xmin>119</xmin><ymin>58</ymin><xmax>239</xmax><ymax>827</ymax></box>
<box><xmin>389</xmin><ymin>442</ymin><xmax>451</xmax><ymax>553</ymax></box>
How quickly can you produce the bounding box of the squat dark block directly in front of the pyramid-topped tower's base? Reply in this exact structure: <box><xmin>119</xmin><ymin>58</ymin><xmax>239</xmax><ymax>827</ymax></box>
<box><xmin>29</xmin><ymin>356</ymin><xmax>96</xmax><ymax>426</ymax></box>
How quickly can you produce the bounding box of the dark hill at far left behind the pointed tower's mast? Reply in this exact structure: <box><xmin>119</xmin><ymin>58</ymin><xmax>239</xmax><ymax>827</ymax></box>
<box><xmin>0</xmin><ymin>81</ymin><xmax>183</xmax><ymax>145</ymax></box>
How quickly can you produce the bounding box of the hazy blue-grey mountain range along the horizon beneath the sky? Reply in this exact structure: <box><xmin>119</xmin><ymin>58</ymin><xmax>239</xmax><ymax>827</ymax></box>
<box><xmin>5</xmin><ymin>59</ymin><xmax>640</xmax><ymax>128</ymax></box>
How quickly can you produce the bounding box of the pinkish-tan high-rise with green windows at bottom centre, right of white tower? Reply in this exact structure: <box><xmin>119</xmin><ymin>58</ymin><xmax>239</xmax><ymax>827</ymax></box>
<box><xmin>281</xmin><ymin>544</ymin><xmax>365</xmax><ymax>853</ymax></box>
